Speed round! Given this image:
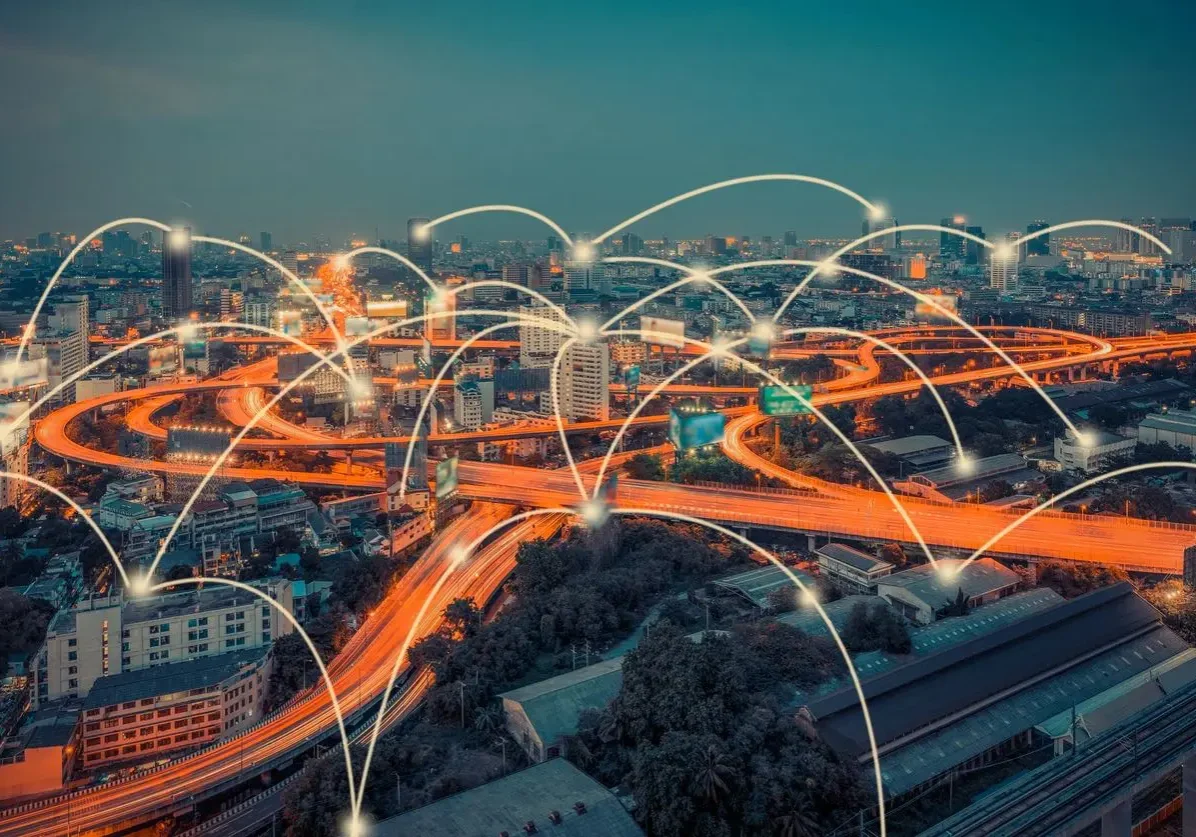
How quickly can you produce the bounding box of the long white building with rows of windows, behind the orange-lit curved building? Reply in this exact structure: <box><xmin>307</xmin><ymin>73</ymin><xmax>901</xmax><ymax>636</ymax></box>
<box><xmin>30</xmin><ymin>579</ymin><xmax>294</xmax><ymax>709</ymax></box>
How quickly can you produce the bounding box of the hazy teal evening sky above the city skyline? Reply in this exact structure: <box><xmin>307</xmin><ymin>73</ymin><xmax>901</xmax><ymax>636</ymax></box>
<box><xmin>0</xmin><ymin>0</ymin><xmax>1196</xmax><ymax>243</ymax></box>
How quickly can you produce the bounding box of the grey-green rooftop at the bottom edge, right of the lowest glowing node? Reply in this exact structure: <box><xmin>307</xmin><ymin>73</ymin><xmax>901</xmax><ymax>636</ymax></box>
<box><xmin>373</xmin><ymin>758</ymin><xmax>643</xmax><ymax>837</ymax></box>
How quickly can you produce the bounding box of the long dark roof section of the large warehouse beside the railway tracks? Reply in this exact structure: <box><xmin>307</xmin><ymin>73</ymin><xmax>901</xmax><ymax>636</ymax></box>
<box><xmin>808</xmin><ymin>584</ymin><xmax>1162</xmax><ymax>756</ymax></box>
